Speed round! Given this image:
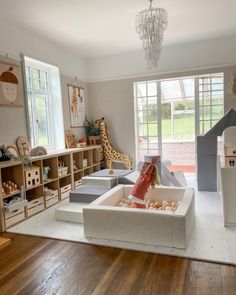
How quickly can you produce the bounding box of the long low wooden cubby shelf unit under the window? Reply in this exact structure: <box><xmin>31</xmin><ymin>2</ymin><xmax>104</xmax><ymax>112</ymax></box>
<box><xmin>0</xmin><ymin>145</ymin><xmax>101</xmax><ymax>232</ymax></box>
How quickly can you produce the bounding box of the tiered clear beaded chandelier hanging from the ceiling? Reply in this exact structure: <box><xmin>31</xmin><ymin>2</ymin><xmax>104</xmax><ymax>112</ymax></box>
<box><xmin>135</xmin><ymin>0</ymin><xmax>168</xmax><ymax>69</ymax></box>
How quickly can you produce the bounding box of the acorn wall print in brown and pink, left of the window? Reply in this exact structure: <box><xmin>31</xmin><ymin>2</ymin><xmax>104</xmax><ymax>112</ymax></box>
<box><xmin>0</xmin><ymin>61</ymin><xmax>24</xmax><ymax>107</ymax></box>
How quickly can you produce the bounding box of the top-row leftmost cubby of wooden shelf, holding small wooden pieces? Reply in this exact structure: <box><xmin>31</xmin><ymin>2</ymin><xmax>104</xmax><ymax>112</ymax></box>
<box><xmin>1</xmin><ymin>165</ymin><xmax>24</xmax><ymax>198</ymax></box>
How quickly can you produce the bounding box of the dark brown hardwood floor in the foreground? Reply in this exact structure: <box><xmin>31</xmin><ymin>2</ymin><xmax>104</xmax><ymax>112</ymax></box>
<box><xmin>0</xmin><ymin>233</ymin><xmax>236</xmax><ymax>295</ymax></box>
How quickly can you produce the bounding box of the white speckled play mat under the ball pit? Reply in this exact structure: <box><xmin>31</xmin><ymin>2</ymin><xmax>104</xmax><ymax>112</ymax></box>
<box><xmin>8</xmin><ymin>177</ymin><xmax>236</xmax><ymax>264</ymax></box>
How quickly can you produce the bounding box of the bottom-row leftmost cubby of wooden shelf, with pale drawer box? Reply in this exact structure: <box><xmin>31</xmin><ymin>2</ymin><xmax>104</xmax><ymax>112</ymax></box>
<box><xmin>4</xmin><ymin>195</ymin><xmax>27</xmax><ymax>228</ymax></box>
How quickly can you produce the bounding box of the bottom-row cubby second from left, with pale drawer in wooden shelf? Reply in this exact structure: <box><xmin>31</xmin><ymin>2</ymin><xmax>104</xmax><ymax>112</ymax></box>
<box><xmin>26</xmin><ymin>185</ymin><xmax>45</xmax><ymax>216</ymax></box>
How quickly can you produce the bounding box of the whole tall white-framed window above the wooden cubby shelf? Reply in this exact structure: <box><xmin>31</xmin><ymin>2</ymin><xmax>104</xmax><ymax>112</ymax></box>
<box><xmin>24</xmin><ymin>57</ymin><xmax>65</xmax><ymax>150</ymax></box>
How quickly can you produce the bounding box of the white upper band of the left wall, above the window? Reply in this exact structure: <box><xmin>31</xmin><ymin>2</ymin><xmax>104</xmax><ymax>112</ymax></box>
<box><xmin>0</xmin><ymin>20</ymin><xmax>87</xmax><ymax>81</ymax></box>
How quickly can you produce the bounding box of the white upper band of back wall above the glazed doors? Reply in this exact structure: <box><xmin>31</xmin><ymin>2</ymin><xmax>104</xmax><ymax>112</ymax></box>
<box><xmin>87</xmin><ymin>36</ymin><xmax>236</xmax><ymax>82</ymax></box>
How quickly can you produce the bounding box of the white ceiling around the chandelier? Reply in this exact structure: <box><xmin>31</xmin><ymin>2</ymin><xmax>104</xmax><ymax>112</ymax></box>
<box><xmin>0</xmin><ymin>0</ymin><xmax>236</xmax><ymax>58</ymax></box>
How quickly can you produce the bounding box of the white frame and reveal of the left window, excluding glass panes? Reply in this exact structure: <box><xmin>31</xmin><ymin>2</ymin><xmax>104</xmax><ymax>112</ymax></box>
<box><xmin>22</xmin><ymin>56</ymin><xmax>65</xmax><ymax>152</ymax></box>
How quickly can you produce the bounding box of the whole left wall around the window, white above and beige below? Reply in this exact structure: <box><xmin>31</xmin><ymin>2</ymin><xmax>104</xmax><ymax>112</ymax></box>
<box><xmin>0</xmin><ymin>21</ymin><xmax>88</xmax><ymax>145</ymax></box>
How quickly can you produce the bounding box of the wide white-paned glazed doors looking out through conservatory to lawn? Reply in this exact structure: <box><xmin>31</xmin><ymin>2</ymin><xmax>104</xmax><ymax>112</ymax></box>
<box><xmin>134</xmin><ymin>73</ymin><xmax>224</xmax><ymax>160</ymax></box>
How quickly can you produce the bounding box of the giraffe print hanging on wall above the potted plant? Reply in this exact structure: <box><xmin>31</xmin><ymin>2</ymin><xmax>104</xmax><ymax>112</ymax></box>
<box><xmin>67</xmin><ymin>84</ymin><xmax>85</xmax><ymax>127</ymax></box>
